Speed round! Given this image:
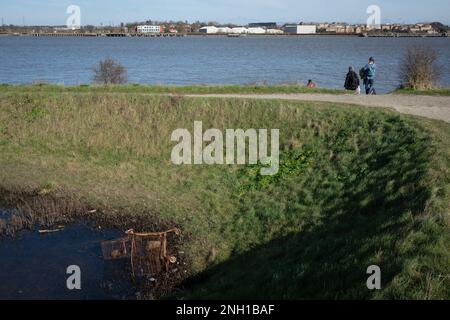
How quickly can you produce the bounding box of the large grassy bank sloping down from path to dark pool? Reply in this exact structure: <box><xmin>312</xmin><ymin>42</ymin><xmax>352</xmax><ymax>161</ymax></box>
<box><xmin>0</xmin><ymin>86</ymin><xmax>450</xmax><ymax>299</ymax></box>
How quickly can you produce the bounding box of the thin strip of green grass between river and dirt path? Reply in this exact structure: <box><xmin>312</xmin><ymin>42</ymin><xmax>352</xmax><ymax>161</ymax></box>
<box><xmin>0</xmin><ymin>84</ymin><xmax>346</xmax><ymax>94</ymax></box>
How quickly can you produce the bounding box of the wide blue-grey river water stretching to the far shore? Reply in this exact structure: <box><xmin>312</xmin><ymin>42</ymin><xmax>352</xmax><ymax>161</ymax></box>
<box><xmin>0</xmin><ymin>36</ymin><xmax>450</xmax><ymax>92</ymax></box>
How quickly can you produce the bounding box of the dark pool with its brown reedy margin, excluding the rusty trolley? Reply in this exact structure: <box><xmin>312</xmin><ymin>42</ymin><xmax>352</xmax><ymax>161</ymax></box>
<box><xmin>0</xmin><ymin>190</ymin><xmax>189</xmax><ymax>299</ymax></box>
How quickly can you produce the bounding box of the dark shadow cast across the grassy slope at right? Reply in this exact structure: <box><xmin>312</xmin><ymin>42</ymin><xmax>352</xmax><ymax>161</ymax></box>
<box><xmin>177</xmin><ymin>120</ymin><xmax>432</xmax><ymax>299</ymax></box>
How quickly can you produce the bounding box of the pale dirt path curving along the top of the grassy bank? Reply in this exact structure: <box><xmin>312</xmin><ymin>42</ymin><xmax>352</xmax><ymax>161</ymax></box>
<box><xmin>189</xmin><ymin>94</ymin><xmax>450</xmax><ymax>123</ymax></box>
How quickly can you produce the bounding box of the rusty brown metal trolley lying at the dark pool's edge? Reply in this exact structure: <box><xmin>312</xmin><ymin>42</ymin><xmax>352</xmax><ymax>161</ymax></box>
<box><xmin>101</xmin><ymin>228</ymin><xmax>180</xmax><ymax>279</ymax></box>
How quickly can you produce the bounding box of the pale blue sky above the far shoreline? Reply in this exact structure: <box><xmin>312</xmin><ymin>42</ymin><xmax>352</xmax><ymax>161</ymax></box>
<box><xmin>0</xmin><ymin>0</ymin><xmax>450</xmax><ymax>25</ymax></box>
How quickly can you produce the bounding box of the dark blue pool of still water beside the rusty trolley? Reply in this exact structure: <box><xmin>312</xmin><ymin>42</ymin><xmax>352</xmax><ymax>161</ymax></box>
<box><xmin>0</xmin><ymin>210</ymin><xmax>135</xmax><ymax>300</ymax></box>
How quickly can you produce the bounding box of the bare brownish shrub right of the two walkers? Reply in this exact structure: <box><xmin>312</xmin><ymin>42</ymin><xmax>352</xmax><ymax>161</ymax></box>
<box><xmin>400</xmin><ymin>46</ymin><xmax>441</xmax><ymax>90</ymax></box>
